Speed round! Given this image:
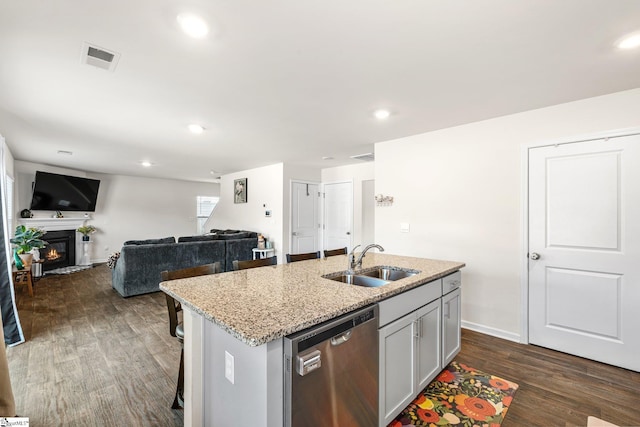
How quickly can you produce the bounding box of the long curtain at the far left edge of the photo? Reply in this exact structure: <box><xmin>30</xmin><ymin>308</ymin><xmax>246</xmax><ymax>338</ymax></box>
<box><xmin>0</xmin><ymin>136</ymin><xmax>24</xmax><ymax>346</ymax></box>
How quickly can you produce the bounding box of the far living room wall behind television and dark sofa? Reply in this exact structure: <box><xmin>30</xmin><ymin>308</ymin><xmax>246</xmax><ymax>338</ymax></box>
<box><xmin>15</xmin><ymin>161</ymin><xmax>219</xmax><ymax>262</ymax></box>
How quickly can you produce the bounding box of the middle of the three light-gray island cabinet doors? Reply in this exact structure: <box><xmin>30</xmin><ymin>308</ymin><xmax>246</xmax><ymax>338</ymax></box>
<box><xmin>415</xmin><ymin>299</ymin><xmax>442</xmax><ymax>394</ymax></box>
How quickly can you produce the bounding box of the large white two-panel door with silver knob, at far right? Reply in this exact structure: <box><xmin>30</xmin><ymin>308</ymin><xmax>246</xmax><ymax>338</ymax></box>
<box><xmin>529</xmin><ymin>135</ymin><xmax>640</xmax><ymax>371</ymax></box>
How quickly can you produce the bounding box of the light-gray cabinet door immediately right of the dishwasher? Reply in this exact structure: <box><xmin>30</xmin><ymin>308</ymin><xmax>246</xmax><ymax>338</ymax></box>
<box><xmin>378</xmin><ymin>313</ymin><xmax>416</xmax><ymax>427</ymax></box>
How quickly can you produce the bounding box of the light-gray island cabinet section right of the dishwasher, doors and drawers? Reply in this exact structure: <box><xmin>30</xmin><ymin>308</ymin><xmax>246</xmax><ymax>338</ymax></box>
<box><xmin>378</xmin><ymin>271</ymin><xmax>462</xmax><ymax>427</ymax></box>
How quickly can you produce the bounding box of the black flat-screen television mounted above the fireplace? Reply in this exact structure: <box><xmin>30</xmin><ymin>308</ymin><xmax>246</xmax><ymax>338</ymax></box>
<box><xmin>30</xmin><ymin>171</ymin><xmax>100</xmax><ymax>212</ymax></box>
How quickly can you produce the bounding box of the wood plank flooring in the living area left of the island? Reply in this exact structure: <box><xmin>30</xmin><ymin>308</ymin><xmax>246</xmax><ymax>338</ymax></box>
<box><xmin>7</xmin><ymin>264</ymin><xmax>183</xmax><ymax>427</ymax></box>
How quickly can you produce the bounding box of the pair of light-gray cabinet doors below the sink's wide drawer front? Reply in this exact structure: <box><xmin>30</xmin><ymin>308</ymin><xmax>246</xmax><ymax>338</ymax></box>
<box><xmin>378</xmin><ymin>300</ymin><xmax>442</xmax><ymax>426</ymax></box>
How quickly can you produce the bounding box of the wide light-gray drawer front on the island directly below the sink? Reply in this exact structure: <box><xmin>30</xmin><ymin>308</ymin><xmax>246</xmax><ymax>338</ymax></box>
<box><xmin>378</xmin><ymin>276</ymin><xmax>442</xmax><ymax>327</ymax></box>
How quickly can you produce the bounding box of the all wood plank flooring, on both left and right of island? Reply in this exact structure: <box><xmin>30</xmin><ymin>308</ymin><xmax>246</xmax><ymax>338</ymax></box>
<box><xmin>7</xmin><ymin>265</ymin><xmax>640</xmax><ymax>427</ymax></box>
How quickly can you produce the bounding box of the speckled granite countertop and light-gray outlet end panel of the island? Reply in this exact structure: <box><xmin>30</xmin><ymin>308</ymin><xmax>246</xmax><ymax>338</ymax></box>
<box><xmin>160</xmin><ymin>253</ymin><xmax>464</xmax><ymax>426</ymax></box>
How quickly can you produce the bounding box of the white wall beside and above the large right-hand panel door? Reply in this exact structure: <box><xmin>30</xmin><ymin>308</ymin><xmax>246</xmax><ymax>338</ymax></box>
<box><xmin>378</xmin><ymin>89</ymin><xmax>640</xmax><ymax>339</ymax></box>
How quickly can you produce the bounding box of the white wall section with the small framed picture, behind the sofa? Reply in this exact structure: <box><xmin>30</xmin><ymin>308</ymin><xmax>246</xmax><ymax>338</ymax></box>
<box><xmin>204</xmin><ymin>163</ymin><xmax>284</xmax><ymax>263</ymax></box>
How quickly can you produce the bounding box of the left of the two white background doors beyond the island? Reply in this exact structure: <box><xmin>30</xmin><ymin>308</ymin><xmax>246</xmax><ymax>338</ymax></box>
<box><xmin>290</xmin><ymin>182</ymin><xmax>320</xmax><ymax>254</ymax></box>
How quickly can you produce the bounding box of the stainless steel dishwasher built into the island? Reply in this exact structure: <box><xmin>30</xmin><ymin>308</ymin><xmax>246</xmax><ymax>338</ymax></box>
<box><xmin>284</xmin><ymin>305</ymin><xmax>378</xmax><ymax>427</ymax></box>
